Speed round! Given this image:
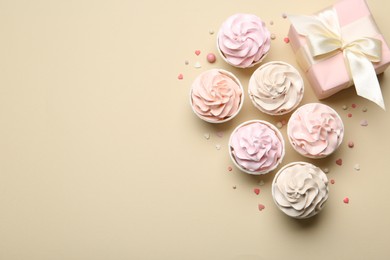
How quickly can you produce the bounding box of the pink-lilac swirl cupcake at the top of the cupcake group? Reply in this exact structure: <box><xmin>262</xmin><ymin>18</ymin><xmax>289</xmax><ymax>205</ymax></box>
<box><xmin>217</xmin><ymin>14</ymin><xmax>271</xmax><ymax>68</ymax></box>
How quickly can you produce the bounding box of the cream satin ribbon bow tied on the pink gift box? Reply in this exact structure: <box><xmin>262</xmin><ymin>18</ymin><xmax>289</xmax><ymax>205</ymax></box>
<box><xmin>289</xmin><ymin>9</ymin><xmax>385</xmax><ymax>109</ymax></box>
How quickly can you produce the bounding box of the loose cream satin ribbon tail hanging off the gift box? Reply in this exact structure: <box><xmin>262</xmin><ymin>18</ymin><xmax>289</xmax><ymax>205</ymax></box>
<box><xmin>344</xmin><ymin>50</ymin><xmax>386</xmax><ymax>110</ymax></box>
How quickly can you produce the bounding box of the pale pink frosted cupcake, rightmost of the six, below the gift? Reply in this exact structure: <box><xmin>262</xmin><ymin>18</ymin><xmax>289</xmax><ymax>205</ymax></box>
<box><xmin>287</xmin><ymin>103</ymin><xmax>344</xmax><ymax>159</ymax></box>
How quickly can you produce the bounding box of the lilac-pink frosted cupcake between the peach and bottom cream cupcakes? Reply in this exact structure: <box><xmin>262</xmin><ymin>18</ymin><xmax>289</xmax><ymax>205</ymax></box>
<box><xmin>229</xmin><ymin>120</ymin><xmax>284</xmax><ymax>175</ymax></box>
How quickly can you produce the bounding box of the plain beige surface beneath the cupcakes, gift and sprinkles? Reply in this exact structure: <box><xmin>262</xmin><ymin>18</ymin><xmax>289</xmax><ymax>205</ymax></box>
<box><xmin>0</xmin><ymin>0</ymin><xmax>390</xmax><ymax>260</ymax></box>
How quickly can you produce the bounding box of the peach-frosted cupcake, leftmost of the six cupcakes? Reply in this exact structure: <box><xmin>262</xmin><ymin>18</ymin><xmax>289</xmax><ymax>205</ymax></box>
<box><xmin>190</xmin><ymin>69</ymin><xmax>244</xmax><ymax>123</ymax></box>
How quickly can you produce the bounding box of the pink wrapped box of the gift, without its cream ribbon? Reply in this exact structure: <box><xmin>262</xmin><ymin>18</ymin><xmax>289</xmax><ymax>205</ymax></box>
<box><xmin>288</xmin><ymin>0</ymin><xmax>390</xmax><ymax>99</ymax></box>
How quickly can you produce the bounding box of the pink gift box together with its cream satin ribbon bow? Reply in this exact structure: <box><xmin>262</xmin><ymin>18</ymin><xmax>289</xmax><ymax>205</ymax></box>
<box><xmin>289</xmin><ymin>0</ymin><xmax>390</xmax><ymax>108</ymax></box>
